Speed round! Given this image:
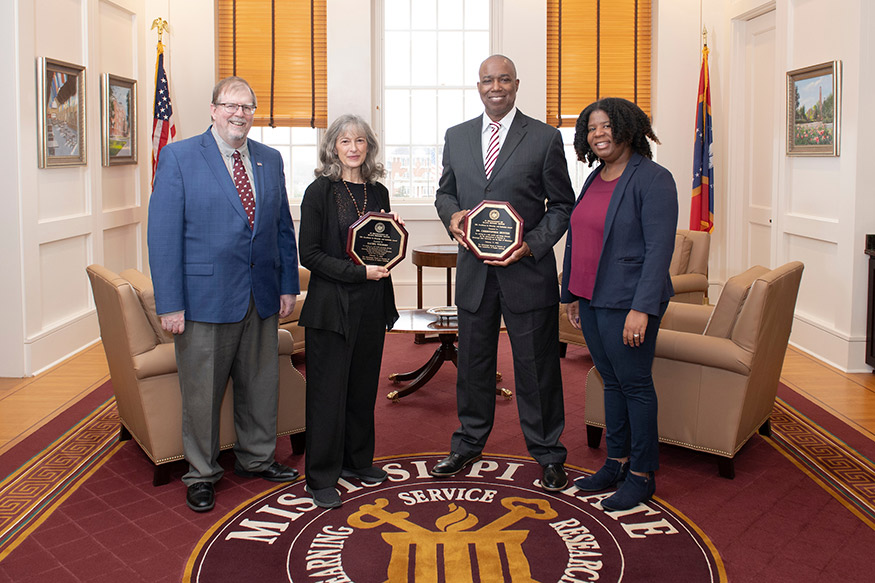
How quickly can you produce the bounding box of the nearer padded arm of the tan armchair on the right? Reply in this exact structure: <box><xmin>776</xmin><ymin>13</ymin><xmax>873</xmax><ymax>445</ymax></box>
<box><xmin>656</xmin><ymin>330</ymin><xmax>751</xmax><ymax>375</ymax></box>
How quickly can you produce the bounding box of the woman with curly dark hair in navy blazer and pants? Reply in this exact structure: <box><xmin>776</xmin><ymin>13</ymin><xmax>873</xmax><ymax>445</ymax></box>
<box><xmin>562</xmin><ymin>98</ymin><xmax>678</xmax><ymax>510</ymax></box>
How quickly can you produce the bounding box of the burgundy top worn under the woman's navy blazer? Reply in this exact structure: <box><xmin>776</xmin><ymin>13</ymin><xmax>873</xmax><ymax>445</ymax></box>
<box><xmin>568</xmin><ymin>173</ymin><xmax>620</xmax><ymax>300</ymax></box>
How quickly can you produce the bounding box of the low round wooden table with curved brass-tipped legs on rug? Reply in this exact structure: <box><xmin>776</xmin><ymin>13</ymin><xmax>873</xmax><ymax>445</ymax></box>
<box><xmin>386</xmin><ymin>309</ymin><xmax>513</xmax><ymax>402</ymax></box>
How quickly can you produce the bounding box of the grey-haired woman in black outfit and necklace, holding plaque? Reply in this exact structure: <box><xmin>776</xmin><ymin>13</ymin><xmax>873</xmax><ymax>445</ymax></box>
<box><xmin>298</xmin><ymin>115</ymin><xmax>398</xmax><ymax>508</ymax></box>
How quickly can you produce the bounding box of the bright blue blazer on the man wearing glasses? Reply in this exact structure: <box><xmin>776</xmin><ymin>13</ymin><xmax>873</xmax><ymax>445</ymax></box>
<box><xmin>148</xmin><ymin>129</ymin><xmax>300</xmax><ymax>323</ymax></box>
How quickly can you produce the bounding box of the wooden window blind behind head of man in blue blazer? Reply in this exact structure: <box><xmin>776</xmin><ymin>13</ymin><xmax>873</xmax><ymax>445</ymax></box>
<box><xmin>216</xmin><ymin>0</ymin><xmax>328</xmax><ymax>128</ymax></box>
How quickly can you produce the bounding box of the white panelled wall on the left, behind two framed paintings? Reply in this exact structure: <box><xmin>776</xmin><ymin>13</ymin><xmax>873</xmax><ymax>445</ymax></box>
<box><xmin>0</xmin><ymin>0</ymin><xmax>149</xmax><ymax>376</ymax></box>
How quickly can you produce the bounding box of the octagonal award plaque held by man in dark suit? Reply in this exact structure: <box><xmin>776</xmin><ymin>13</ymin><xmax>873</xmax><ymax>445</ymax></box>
<box><xmin>462</xmin><ymin>200</ymin><xmax>524</xmax><ymax>264</ymax></box>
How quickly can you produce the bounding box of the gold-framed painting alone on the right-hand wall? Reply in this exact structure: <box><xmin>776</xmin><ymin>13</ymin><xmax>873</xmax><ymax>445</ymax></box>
<box><xmin>787</xmin><ymin>61</ymin><xmax>842</xmax><ymax>156</ymax></box>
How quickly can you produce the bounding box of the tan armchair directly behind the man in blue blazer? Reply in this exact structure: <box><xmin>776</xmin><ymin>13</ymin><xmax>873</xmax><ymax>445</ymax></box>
<box><xmin>87</xmin><ymin>265</ymin><xmax>306</xmax><ymax>486</ymax></box>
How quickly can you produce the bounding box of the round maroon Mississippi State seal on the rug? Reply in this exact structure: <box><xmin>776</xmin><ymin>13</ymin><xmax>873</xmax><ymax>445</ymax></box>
<box><xmin>184</xmin><ymin>454</ymin><xmax>726</xmax><ymax>583</ymax></box>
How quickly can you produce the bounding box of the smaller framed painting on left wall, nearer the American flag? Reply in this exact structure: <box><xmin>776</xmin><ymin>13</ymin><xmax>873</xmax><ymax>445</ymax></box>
<box><xmin>100</xmin><ymin>73</ymin><xmax>137</xmax><ymax>166</ymax></box>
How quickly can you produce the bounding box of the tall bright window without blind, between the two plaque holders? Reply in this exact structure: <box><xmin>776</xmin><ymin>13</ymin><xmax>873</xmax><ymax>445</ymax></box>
<box><xmin>382</xmin><ymin>0</ymin><xmax>490</xmax><ymax>199</ymax></box>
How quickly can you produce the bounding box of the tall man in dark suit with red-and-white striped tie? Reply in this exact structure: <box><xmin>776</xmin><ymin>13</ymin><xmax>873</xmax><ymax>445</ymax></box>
<box><xmin>431</xmin><ymin>55</ymin><xmax>574</xmax><ymax>491</ymax></box>
